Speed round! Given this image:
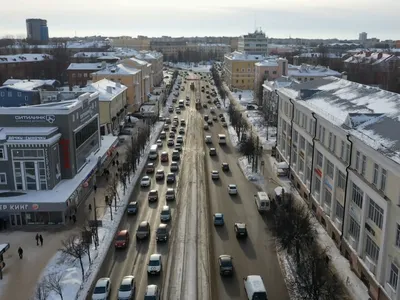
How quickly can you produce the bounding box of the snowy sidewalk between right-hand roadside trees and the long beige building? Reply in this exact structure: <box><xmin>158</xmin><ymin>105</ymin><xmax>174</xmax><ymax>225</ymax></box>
<box><xmin>224</xmin><ymin>83</ymin><xmax>369</xmax><ymax>300</ymax></box>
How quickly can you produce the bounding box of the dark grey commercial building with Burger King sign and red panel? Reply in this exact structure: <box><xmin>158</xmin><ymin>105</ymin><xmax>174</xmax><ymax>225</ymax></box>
<box><xmin>0</xmin><ymin>93</ymin><xmax>117</xmax><ymax>227</ymax></box>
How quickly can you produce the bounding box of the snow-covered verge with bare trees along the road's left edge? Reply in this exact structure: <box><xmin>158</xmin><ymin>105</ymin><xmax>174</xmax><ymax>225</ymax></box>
<box><xmin>36</xmin><ymin>122</ymin><xmax>163</xmax><ymax>300</ymax></box>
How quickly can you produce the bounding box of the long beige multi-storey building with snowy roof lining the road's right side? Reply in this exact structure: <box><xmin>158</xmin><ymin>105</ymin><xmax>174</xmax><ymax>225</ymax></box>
<box><xmin>277</xmin><ymin>77</ymin><xmax>400</xmax><ymax>300</ymax></box>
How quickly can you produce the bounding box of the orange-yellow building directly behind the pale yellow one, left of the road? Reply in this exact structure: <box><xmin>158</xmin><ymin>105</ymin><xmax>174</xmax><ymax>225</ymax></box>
<box><xmin>92</xmin><ymin>64</ymin><xmax>143</xmax><ymax>112</ymax></box>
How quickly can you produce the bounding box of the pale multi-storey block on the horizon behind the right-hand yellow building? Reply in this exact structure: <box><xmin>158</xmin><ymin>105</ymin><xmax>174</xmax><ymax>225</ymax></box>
<box><xmin>238</xmin><ymin>30</ymin><xmax>268</xmax><ymax>55</ymax></box>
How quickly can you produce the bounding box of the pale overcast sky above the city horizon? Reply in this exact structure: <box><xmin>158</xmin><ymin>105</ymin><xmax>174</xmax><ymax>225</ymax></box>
<box><xmin>0</xmin><ymin>0</ymin><xmax>400</xmax><ymax>40</ymax></box>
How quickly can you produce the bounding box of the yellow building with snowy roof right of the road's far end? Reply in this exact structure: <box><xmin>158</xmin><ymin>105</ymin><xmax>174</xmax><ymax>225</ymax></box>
<box><xmin>224</xmin><ymin>51</ymin><xmax>265</xmax><ymax>90</ymax></box>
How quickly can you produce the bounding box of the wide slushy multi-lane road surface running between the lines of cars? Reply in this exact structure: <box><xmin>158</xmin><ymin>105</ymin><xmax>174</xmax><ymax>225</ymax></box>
<box><xmin>88</xmin><ymin>71</ymin><xmax>289</xmax><ymax>300</ymax></box>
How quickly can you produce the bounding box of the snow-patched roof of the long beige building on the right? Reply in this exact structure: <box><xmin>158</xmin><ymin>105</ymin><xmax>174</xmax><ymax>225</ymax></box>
<box><xmin>278</xmin><ymin>77</ymin><xmax>400</xmax><ymax>164</ymax></box>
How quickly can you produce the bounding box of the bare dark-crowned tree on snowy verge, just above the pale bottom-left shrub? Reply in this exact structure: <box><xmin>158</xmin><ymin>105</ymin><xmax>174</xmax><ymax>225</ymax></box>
<box><xmin>60</xmin><ymin>234</ymin><xmax>91</xmax><ymax>279</ymax></box>
